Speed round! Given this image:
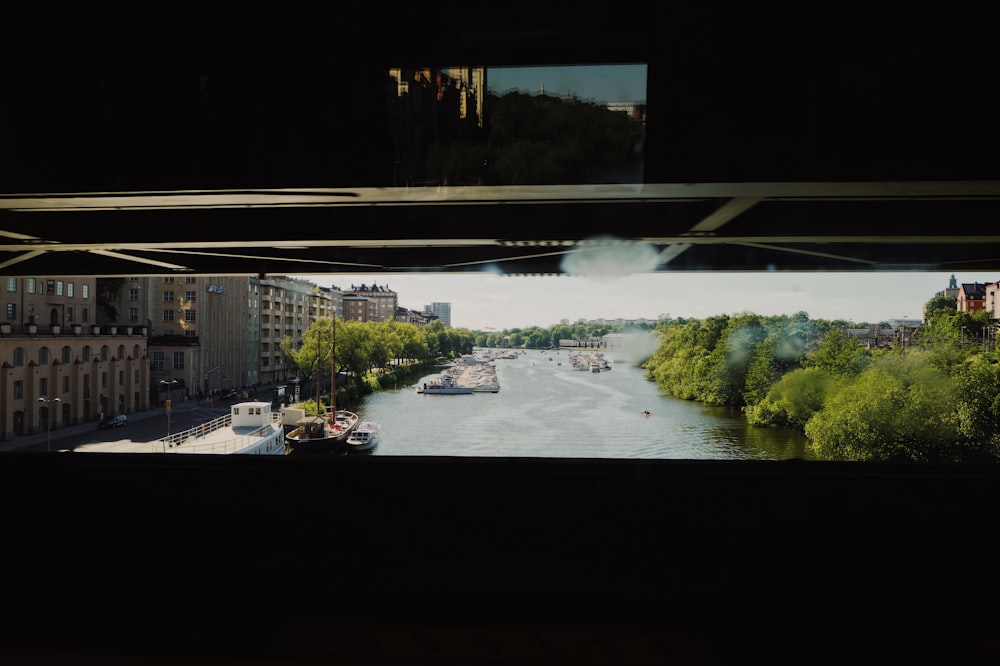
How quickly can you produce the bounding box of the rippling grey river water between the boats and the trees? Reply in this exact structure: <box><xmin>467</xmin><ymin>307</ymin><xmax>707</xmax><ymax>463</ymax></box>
<box><xmin>340</xmin><ymin>350</ymin><xmax>810</xmax><ymax>460</ymax></box>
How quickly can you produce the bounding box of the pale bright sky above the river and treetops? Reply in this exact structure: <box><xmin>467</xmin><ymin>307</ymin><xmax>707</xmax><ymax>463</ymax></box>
<box><xmin>299</xmin><ymin>272</ymin><xmax>1000</xmax><ymax>331</ymax></box>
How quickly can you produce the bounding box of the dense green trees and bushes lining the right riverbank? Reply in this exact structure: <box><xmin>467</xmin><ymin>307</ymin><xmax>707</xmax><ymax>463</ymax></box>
<box><xmin>643</xmin><ymin>308</ymin><xmax>1000</xmax><ymax>463</ymax></box>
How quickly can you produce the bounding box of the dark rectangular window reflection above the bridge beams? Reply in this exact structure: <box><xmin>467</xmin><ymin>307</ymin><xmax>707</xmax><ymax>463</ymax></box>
<box><xmin>388</xmin><ymin>65</ymin><xmax>646</xmax><ymax>187</ymax></box>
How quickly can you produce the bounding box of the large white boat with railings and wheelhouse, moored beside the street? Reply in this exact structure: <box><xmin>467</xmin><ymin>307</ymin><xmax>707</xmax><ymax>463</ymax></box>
<box><xmin>73</xmin><ymin>401</ymin><xmax>288</xmax><ymax>456</ymax></box>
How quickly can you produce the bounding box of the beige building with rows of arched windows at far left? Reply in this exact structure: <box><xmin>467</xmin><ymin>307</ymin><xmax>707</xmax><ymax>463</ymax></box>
<box><xmin>0</xmin><ymin>277</ymin><xmax>149</xmax><ymax>440</ymax></box>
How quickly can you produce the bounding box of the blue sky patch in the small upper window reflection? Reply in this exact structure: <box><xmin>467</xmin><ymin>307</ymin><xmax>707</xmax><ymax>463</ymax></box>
<box><xmin>486</xmin><ymin>65</ymin><xmax>646</xmax><ymax>102</ymax></box>
